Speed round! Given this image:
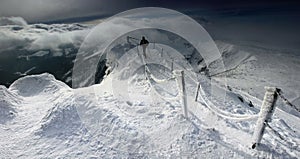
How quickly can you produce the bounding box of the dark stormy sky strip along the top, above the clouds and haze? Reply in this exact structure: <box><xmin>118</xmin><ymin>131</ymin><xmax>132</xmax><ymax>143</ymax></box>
<box><xmin>0</xmin><ymin>0</ymin><xmax>299</xmax><ymax>23</ymax></box>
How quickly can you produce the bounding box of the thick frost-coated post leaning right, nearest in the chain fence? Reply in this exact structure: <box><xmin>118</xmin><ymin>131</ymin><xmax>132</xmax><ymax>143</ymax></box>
<box><xmin>252</xmin><ymin>87</ymin><xmax>280</xmax><ymax>149</ymax></box>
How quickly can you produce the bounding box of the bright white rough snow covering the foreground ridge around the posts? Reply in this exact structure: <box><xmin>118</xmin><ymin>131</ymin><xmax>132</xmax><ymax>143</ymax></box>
<box><xmin>0</xmin><ymin>43</ymin><xmax>300</xmax><ymax>158</ymax></box>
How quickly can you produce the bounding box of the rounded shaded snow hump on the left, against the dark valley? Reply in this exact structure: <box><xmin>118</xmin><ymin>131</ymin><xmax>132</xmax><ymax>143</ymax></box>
<box><xmin>9</xmin><ymin>73</ymin><xmax>69</xmax><ymax>97</ymax></box>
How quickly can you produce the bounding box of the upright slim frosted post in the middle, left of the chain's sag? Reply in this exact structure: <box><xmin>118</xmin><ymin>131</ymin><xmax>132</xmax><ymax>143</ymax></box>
<box><xmin>173</xmin><ymin>70</ymin><xmax>188</xmax><ymax>118</ymax></box>
